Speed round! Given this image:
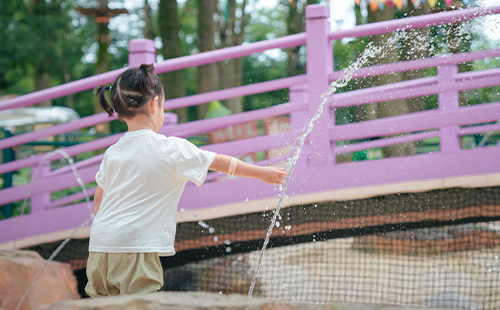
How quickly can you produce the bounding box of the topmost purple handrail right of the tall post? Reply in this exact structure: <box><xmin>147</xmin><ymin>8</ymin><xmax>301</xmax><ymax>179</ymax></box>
<box><xmin>329</xmin><ymin>6</ymin><xmax>500</xmax><ymax>40</ymax></box>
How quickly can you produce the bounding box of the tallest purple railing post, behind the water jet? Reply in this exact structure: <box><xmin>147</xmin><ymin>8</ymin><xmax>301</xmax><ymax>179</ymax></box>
<box><xmin>306</xmin><ymin>4</ymin><xmax>334</xmax><ymax>166</ymax></box>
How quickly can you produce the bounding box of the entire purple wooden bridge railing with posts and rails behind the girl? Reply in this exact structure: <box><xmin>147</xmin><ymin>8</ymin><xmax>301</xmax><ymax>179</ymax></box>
<box><xmin>0</xmin><ymin>5</ymin><xmax>500</xmax><ymax>247</ymax></box>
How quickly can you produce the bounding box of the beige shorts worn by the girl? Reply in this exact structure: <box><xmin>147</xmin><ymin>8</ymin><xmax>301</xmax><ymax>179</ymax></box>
<box><xmin>85</xmin><ymin>252</ymin><xmax>163</xmax><ymax>298</ymax></box>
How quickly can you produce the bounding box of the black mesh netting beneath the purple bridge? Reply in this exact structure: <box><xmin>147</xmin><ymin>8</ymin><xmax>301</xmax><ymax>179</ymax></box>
<box><xmin>30</xmin><ymin>187</ymin><xmax>500</xmax><ymax>310</ymax></box>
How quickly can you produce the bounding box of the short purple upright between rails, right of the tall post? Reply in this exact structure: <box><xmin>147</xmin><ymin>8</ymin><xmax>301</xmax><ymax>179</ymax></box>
<box><xmin>437</xmin><ymin>65</ymin><xmax>461</xmax><ymax>152</ymax></box>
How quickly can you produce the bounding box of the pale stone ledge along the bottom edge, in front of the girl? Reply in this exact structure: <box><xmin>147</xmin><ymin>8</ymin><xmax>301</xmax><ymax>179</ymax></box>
<box><xmin>37</xmin><ymin>292</ymin><xmax>450</xmax><ymax>310</ymax></box>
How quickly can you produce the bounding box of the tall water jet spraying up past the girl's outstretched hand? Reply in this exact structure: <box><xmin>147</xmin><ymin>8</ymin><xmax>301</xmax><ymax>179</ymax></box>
<box><xmin>248</xmin><ymin>30</ymin><xmax>406</xmax><ymax>297</ymax></box>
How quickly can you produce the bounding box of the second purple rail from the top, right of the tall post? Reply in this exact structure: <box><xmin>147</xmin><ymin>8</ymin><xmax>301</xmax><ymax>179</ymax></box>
<box><xmin>329</xmin><ymin>49</ymin><xmax>500</xmax><ymax>82</ymax></box>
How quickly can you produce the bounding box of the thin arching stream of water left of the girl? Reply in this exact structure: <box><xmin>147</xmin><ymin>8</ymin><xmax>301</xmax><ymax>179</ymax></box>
<box><xmin>12</xmin><ymin>149</ymin><xmax>94</xmax><ymax>310</ymax></box>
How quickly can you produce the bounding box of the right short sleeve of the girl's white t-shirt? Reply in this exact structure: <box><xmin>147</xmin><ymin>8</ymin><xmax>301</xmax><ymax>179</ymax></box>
<box><xmin>177</xmin><ymin>139</ymin><xmax>216</xmax><ymax>186</ymax></box>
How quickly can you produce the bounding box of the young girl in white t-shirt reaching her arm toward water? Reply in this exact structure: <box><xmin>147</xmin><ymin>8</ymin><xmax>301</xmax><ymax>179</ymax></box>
<box><xmin>85</xmin><ymin>65</ymin><xmax>286</xmax><ymax>297</ymax></box>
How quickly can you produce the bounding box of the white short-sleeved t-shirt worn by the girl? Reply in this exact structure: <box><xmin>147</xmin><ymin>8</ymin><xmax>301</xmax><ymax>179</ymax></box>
<box><xmin>89</xmin><ymin>130</ymin><xmax>216</xmax><ymax>256</ymax></box>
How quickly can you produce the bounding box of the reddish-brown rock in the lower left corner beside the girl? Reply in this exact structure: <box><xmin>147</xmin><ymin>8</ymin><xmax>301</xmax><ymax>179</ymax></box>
<box><xmin>0</xmin><ymin>251</ymin><xmax>80</xmax><ymax>310</ymax></box>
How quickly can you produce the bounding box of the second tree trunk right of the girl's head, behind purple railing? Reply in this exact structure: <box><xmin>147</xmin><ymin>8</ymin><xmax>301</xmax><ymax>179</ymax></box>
<box><xmin>197</xmin><ymin>0</ymin><xmax>218</xmax><ymax>119</ymax></box>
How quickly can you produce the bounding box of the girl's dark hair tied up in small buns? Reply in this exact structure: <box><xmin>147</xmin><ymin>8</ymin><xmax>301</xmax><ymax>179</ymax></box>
<box><xmin>94</xmin><ymin>64</ymin><xmax>165</xmax><ymax>121</ymax></box>
